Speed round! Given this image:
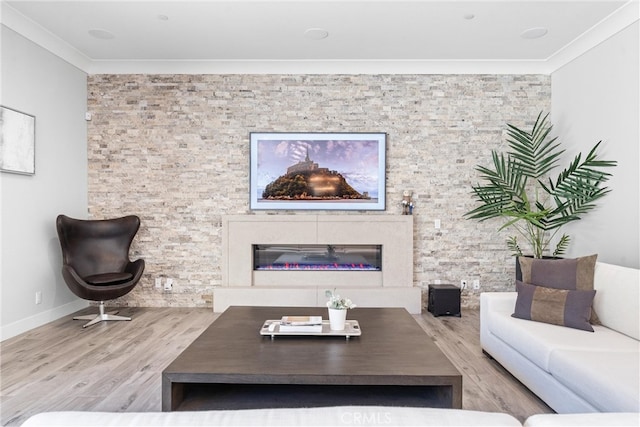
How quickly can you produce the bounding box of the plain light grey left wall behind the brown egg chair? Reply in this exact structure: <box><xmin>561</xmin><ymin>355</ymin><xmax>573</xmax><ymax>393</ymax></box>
<box><xmin>0</xmin><ymin>26</ymin><xmax>87</xmax><ymax>339</ymax></box>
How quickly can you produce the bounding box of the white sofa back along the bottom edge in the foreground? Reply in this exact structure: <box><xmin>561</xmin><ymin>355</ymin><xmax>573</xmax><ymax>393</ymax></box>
<box><xmin>22</xmin><ymin>406</ymin><xmax>640</xmax><ymax>427</ymax></box>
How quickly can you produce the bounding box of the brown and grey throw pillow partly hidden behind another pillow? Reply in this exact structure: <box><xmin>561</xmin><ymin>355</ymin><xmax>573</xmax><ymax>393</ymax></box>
<box><xmin>518</xmin><ymin>254</ymin><xmax>600</xmax><ymax>324</ymax></box>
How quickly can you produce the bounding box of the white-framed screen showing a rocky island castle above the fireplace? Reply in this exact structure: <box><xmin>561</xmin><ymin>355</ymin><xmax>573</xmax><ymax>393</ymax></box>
<box><xmin>250</xmin><ymin>132</ymin><xmax>387</xmax><ymax>210</ymax></box>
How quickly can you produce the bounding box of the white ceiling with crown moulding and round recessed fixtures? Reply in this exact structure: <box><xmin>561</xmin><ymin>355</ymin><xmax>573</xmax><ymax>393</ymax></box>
<box><xmin>0</xmin><ymin>0</ymin><xmax>640</xmax><ymax>73</ymax></box>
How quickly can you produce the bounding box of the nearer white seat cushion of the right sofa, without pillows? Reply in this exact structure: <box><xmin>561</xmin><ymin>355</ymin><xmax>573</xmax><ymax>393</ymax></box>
<box><xmin>549</xmin><ymin>350</ymin><xmax>640</xmax><ymax>412</ymax></box>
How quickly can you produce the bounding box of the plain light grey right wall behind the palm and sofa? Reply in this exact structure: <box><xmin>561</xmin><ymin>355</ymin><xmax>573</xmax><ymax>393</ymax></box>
<box><xmin>551</xmin><ymin>22</ymin><xmax>640</xmax><ymax>268</ymax></box>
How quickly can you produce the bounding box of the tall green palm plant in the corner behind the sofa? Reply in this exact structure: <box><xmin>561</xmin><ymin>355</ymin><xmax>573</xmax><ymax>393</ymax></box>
<box><xmin>465</xmin><ymin>112</ymin><xmax>616</xmax><ymax>258</ymax></box>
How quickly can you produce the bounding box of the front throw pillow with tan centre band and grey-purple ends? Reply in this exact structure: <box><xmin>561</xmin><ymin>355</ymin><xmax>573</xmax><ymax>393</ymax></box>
<box><xmin>513</xmin><ymin>280</ymin><xmax>596</xmax><ymax>332</ymax></box>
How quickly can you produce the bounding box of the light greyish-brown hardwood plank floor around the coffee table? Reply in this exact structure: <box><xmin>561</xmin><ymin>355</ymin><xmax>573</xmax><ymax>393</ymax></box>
<box><xmin>0</xmin><ymin>308</ymin><xmax>552</xmax><ymax>426</ymax></box>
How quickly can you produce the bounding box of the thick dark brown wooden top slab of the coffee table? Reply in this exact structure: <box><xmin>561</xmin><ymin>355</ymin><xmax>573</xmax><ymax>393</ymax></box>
<box><xmin>163</xmin><ymin>306</ymin><xmax>462</xmax><ymax>385</ymax></box>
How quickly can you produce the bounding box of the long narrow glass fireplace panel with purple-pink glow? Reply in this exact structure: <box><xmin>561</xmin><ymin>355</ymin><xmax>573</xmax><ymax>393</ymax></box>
<box><xmin>253</xmin><ymin>244</ymin><xmax>382</xmax><ymax>271</ymax></box>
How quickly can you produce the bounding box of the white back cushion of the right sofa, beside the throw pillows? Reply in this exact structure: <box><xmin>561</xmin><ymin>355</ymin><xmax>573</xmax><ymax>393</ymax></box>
<box><xmin>593</xmin><ymin>262</ymin><xmax>640</xmax><ymax>340</ymax></box>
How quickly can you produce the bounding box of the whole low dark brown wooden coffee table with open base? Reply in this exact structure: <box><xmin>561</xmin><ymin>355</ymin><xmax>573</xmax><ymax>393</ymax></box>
<box><xmin>162</xmin><ymin>307</ymin><xmax>462</xmax><ymax>411</ymax></box>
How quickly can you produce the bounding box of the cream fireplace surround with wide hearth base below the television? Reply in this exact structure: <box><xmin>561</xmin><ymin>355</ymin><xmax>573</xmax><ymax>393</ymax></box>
<box><xmin>213</xmin><ymin>214</ymin><xmax>422</xmax><ymax>313</ymax></box>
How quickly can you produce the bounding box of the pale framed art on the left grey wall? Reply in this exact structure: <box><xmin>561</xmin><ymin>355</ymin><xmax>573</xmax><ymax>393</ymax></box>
<box><xmin>0</xmin><ymin>106</ymin><xmax>36</xmax><ymax>175</ymax></box>
